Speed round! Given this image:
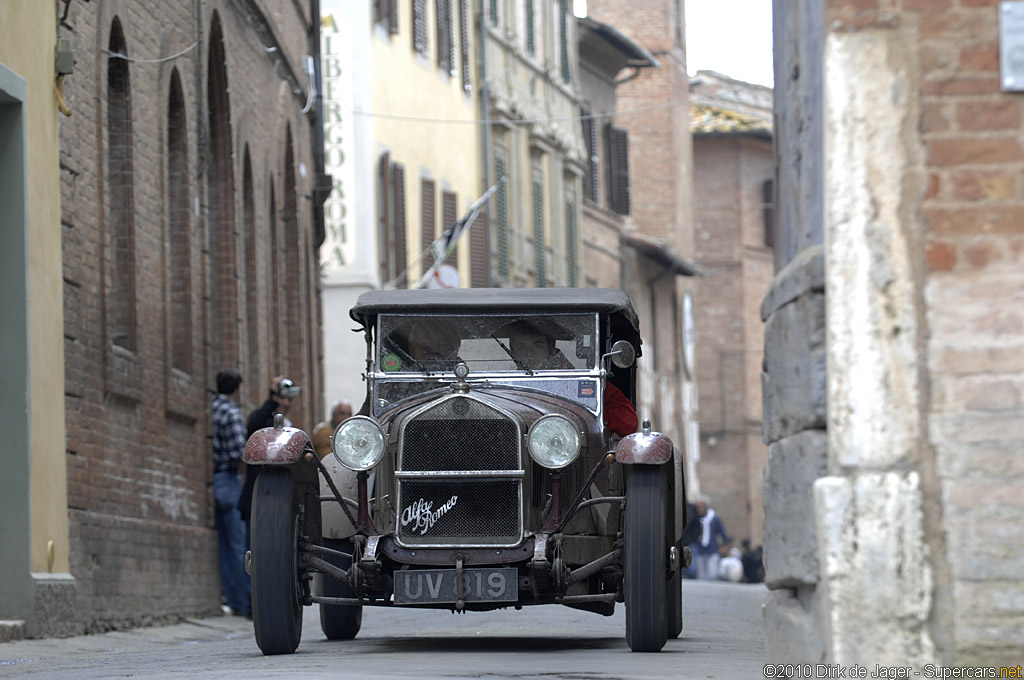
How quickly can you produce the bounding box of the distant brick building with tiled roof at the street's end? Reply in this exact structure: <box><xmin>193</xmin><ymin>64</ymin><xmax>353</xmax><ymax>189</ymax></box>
<box><xmin>690</xmin><ymin>71</ymin><xmax>774</xmax><ymax>547</ymax></box>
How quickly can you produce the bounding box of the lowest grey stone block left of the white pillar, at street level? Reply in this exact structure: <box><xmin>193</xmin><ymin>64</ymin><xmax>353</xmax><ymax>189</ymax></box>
<box><xmin>764</xmin><ymin>588</ymin><xmax>825</xmax><ymax>664</ymax></box>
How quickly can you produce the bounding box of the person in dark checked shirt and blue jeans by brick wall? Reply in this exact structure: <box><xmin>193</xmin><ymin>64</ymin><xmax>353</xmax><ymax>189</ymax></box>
<box><xmin>212</xmin><ymin>369</ymin><xmax>252</xmax><ymax>619</ymax></box>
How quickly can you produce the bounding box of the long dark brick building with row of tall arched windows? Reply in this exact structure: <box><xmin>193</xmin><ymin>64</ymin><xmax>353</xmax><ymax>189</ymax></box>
<box><xmin>51</xmin><ymin>0</ymin><xmax>324</xmax><ymax>631</ymax></box>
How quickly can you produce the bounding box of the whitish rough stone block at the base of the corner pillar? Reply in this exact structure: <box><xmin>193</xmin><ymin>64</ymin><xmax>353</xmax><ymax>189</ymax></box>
<box><xmin>814</xmin><ymin>472</ymin><xmax>935</xmax><ymax>667</ymax></box>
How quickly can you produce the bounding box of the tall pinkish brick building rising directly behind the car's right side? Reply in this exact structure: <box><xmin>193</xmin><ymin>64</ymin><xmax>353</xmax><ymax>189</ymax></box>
<box><xmin>587</xmin><ymin>0</ymin><xmax>700</xmax><ymax>495</ymax></box>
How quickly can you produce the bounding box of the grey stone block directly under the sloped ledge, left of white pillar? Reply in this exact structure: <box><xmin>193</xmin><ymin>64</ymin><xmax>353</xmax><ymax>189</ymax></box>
<box><xmin>761</xmin><ymin>293</ymin><xmax>827</xmax><ymax>443</ymax></box>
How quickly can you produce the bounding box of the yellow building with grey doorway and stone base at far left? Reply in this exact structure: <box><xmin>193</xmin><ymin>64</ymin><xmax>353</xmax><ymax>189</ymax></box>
<box><xmin>0</xmin><ymin>0</ymin><xmax>69</xmax><ymax>641</ymax></box>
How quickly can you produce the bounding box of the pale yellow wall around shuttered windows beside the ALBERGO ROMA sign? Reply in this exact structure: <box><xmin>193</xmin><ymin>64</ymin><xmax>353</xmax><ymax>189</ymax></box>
<box><xmin>371</xmin><ymin>2</ymin><xmax>486</xmax><ymax>288</ymax></box>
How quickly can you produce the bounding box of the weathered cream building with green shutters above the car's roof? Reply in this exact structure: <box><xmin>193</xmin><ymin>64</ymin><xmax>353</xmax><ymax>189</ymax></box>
<box><xmin>474</xmin><ymin>0</ymin><xmax>586</xmax><ymax>288</ymax></box>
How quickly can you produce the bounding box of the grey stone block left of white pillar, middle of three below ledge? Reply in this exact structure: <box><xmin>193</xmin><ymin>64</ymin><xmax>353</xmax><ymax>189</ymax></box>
<box><xmin>763</xmin><ymin>430</ymin><xmax>828</xmax><ymax>589</ymax></box>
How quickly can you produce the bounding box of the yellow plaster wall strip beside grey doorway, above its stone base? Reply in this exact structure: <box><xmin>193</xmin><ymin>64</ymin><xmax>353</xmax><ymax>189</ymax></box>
<box><xmin>0</xmin><ymin>0</ymin><xmax>70</xmax><ymax>573</ymax></box>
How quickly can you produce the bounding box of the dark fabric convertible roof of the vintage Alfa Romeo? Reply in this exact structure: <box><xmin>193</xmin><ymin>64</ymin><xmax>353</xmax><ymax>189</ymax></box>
<box><xmin>349</xmin><ymin>288</ymin><xmax>639</xmax><ymax>333</ymax></box>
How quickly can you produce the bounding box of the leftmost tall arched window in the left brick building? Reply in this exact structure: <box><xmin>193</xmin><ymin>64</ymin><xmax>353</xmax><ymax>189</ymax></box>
<box><xmin>106</xmin><ymin>17</ymin><xmax>136</xmax><ymax>351</ymax></box>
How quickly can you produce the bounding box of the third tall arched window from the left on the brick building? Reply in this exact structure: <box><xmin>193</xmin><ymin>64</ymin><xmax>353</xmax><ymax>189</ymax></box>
<box><xmin>207</xmin><ymin>12</ymin><xmax>241</xmax><ymax>368</ymax></box>
